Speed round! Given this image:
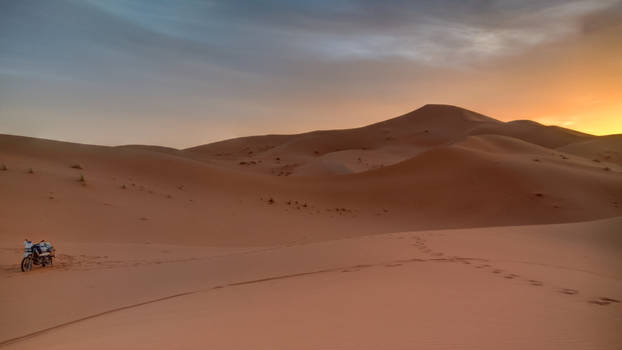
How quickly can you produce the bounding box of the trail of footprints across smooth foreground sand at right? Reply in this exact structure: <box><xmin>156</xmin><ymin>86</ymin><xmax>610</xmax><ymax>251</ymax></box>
<box><xmin>412</xmin><ymin>236</ymin><xmax>620</xmax><ymax>306</ymax></box>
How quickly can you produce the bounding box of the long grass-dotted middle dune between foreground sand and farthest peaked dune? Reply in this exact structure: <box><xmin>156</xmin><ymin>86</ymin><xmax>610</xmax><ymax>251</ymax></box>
<box><xmin>0</xmin><ymin>129</ymin><xmax>622</xmax><ymax>244</ymax></box>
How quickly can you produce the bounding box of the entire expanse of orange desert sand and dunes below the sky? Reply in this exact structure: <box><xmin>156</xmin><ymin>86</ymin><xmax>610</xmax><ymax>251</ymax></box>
<box><xmin>0</xmin><ymin>105</ymin><xmax>622</xmax><ymax>349</ymax></box>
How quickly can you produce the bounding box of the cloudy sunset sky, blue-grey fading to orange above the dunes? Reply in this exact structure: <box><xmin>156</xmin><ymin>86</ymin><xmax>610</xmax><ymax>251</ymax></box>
<box><xmin>0</xmin><ymin>0</ymin><xmax>622</xmax><ymax>148</ymax></box>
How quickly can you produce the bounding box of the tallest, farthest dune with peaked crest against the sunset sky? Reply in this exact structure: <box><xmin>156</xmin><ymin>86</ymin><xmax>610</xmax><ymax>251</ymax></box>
<box><xmin>180</xmin><ymin>105</ymin><xmax>608</xmax><ymax>176</ymax></box>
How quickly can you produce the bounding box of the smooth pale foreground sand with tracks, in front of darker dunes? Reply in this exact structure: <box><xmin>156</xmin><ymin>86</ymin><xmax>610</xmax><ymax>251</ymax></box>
<box><xmin>0</xmin><ymin>218</ymin><xmax>622</xmax><ymax>349</ymax></box>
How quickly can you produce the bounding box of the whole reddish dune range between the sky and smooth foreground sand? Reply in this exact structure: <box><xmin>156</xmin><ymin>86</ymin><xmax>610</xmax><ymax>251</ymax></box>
<box><xmin>0</xmin><ymin>105</ymin><xmax>622</xmax><ymax>245</ymax></box>
